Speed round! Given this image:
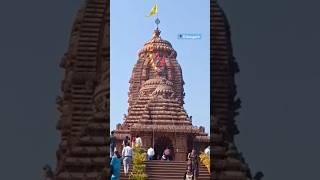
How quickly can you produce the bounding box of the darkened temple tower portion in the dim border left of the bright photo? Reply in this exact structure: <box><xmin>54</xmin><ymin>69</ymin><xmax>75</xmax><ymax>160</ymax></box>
<box><xmin>53</xmin><ymin>0</ymin><xmax>109</xmax><ymax>180</ymax></box>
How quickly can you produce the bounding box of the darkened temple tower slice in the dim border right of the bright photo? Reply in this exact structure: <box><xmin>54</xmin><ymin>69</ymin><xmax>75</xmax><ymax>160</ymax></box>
<box><xmin>211</xmin><ymin>0</ymin><xmax>252</xmax><ymax>180</ymax></box>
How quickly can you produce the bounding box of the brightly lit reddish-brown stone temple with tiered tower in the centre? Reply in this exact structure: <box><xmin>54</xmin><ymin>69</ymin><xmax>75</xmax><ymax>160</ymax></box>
<box><xmin>115</xmin><ymin>28</ymin><xmax>209</xmax><ymax>161</ymax></box>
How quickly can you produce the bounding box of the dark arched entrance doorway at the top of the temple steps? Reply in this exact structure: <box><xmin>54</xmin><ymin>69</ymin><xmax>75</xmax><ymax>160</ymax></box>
<box><xmin>154</xmin><ymin>136</ymin><xmax>174</xmax><ymax>160</ymax></box>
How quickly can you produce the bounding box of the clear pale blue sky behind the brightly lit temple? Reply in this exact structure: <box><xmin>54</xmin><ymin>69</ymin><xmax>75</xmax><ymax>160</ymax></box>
<box><xmin>110</xmin><ymin>0</ymin><xmax>210</xmax><ymax>132</ymax></box>
